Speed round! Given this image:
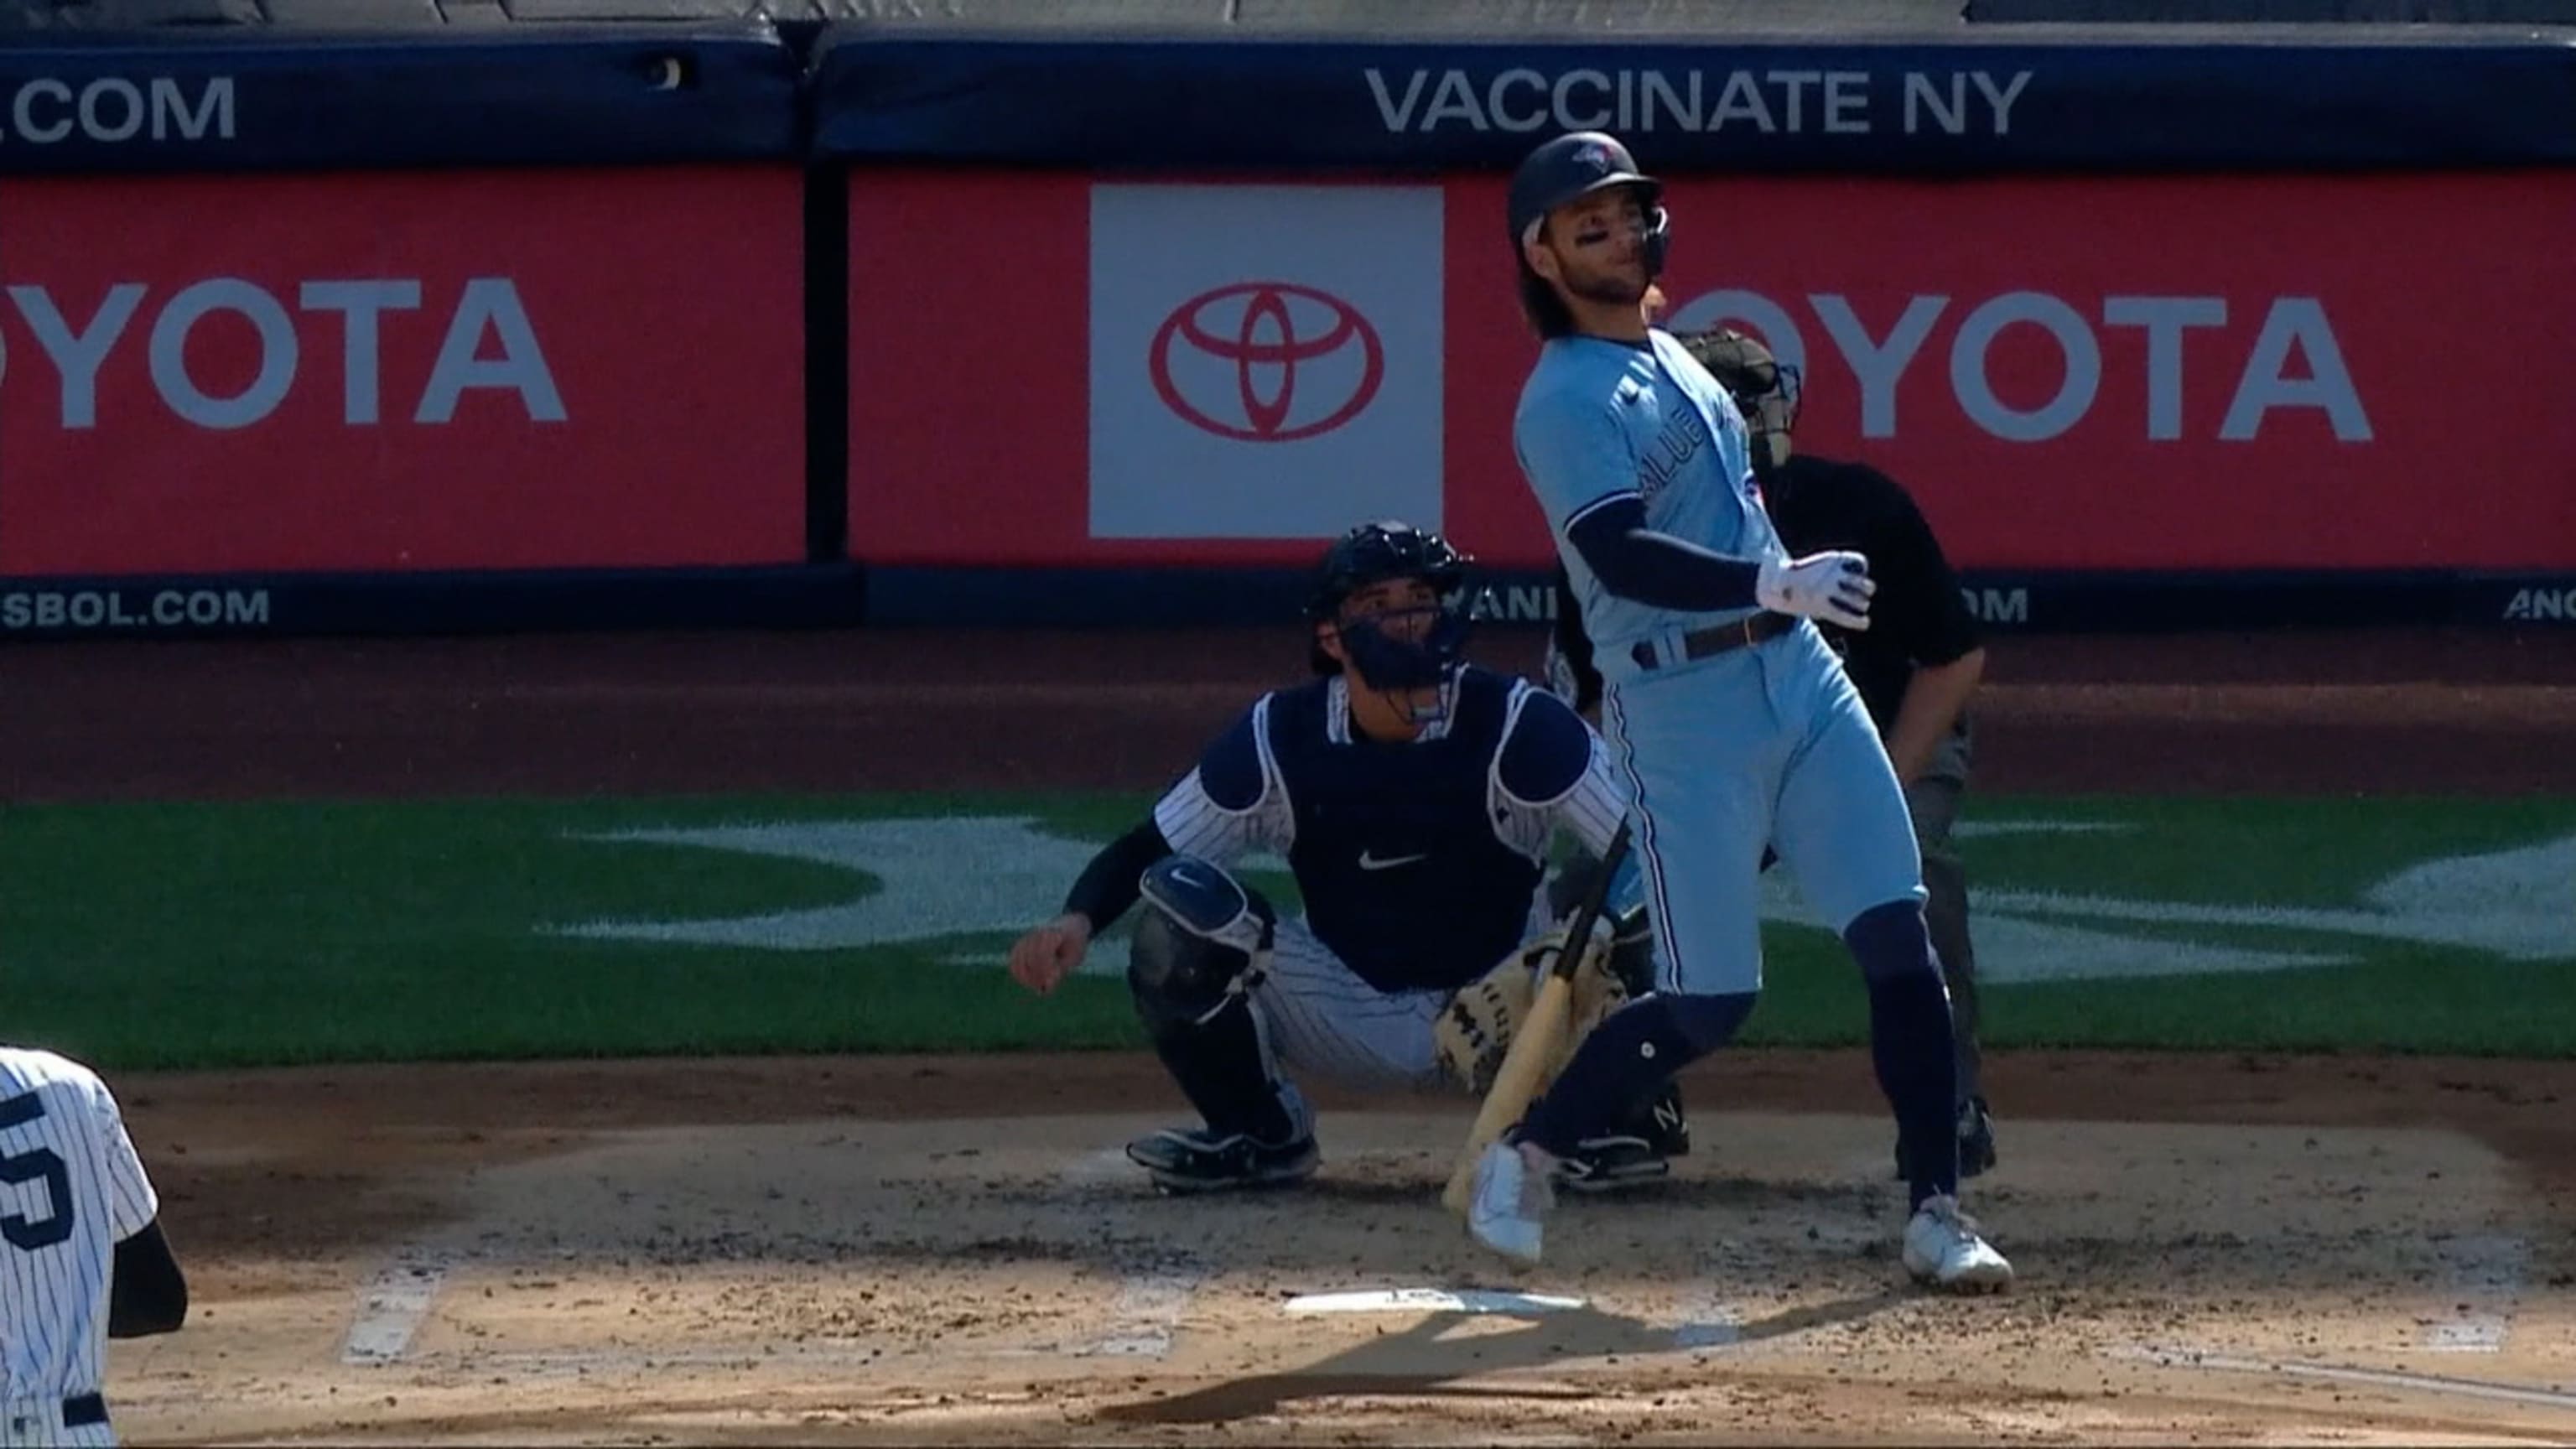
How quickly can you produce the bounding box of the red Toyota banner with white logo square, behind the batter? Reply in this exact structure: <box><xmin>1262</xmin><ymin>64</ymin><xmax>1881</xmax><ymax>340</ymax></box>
<box><xmin>850</xmin><ymin>173</ymin><xmax>2576</xmax><ymax>570</ymax></box>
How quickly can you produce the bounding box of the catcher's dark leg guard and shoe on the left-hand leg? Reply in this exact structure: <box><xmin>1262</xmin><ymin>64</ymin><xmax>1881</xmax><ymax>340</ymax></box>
<box><xmin>1129</xmin><ymin>856</ymin><xmax>1317</xmax><ymax>1192</ymax></box>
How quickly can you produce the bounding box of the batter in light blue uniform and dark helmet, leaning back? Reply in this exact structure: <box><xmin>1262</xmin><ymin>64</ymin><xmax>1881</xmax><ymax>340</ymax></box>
<box><xmin>1468</xmin><ymin>132</ymin><xmax>2012</xmax><ymax>1289</ymax></box>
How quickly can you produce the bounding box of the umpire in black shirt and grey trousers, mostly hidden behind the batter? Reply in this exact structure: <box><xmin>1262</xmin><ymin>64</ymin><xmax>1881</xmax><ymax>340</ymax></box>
<box><xmin>1548</xmin><ymin>327</ymin><xmax>1994</xmax><ymax>1178</ymax></box>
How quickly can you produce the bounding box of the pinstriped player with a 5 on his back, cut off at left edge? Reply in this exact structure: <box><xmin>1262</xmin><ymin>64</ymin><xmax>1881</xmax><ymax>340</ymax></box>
<box><xmin>0</xmin><ymin>1046</ymin><xmax>188</xmax><ymax>1446</ymax></box>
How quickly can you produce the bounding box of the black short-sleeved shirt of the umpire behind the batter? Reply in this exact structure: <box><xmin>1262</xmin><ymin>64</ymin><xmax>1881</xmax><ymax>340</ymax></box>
<box><xmin>1762</xmin><ymin>454</ymin><xmax>1978</xmax><ymax>735</ymax></box>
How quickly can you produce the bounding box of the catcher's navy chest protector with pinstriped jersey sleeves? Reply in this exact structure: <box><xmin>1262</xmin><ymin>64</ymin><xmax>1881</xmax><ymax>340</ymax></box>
<box><xmin>1154</xmin><ymin>665</ymin><xmax>1625</xmax><ymax>993</ymax></box>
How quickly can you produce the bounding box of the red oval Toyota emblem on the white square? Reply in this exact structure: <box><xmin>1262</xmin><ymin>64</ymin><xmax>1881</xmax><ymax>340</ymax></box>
<box><xmin>1149</xmin><ymin>281</ymin><xmax>1386</xmax><ymax>444</ymax></box>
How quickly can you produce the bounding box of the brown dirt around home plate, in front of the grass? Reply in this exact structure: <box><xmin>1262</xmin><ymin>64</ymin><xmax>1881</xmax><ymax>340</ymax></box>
<box><xmin>113</xmin><ymin>1052</ymin><xmax>2576</xmax><ymax>1444</ymax></box>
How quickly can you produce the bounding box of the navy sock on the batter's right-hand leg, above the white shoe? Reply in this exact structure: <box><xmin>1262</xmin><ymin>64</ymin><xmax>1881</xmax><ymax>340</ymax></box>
<box><xmin>1841</xmin><ymin>900</ymin><xmax>1958</xmax><ymax>1207</ymax></box>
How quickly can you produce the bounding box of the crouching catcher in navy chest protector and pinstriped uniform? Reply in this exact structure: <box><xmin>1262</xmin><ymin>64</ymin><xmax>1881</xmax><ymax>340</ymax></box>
<box><xmin>1010</xmin><ymin>521</ymin><xmax>1690</xmax><ymax>1194</ymax></box>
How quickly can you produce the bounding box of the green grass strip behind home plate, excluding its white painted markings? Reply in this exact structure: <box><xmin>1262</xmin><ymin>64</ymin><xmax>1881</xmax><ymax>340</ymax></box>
<box><xmin>0</xmin><ymin>794</ymin><xmax>2576</xmax><ymax>1067</ymax></box>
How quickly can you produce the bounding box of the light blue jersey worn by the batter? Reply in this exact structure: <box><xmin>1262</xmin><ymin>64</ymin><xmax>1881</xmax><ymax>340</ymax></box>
<box><xmin>1512</xmin><ymin>330</ymin><xmax>1783</xmax><ymax>657</ymax></box>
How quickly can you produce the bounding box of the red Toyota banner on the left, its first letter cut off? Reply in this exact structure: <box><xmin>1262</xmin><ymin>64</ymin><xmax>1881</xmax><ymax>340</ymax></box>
<box><xmin>0</xmin><ymin>168</ymin><xmax>803</xmax><ymax>578</ymax></box>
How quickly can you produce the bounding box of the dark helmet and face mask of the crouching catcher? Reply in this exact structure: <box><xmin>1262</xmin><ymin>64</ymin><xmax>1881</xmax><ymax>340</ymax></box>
<box><xmin>1306</xmin><ymin>518</ymin><xmax>1476</xmax><ymax>693</ymax></box>
